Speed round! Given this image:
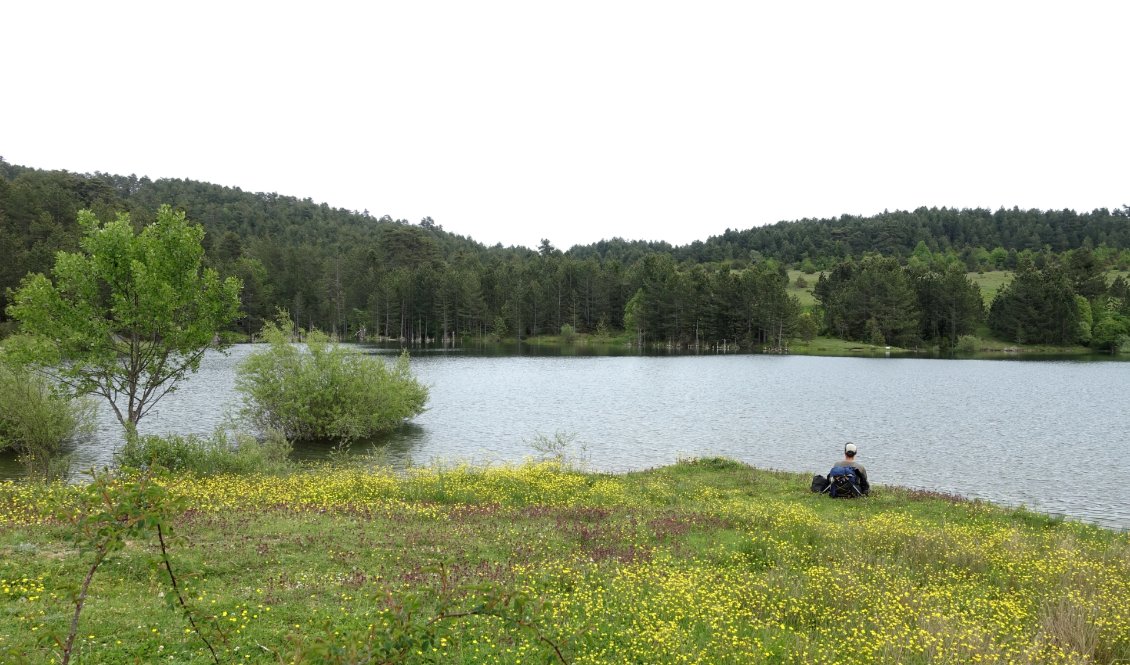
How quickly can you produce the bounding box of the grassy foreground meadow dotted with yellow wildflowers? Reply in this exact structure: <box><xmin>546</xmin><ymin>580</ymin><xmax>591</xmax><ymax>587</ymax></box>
<box><xmin>0</xmin><ymin>459</ymin><xmax>1130</xmax><ymax>664</ymax></box>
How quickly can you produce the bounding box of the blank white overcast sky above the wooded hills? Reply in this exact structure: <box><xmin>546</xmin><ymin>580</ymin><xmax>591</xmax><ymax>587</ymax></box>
<box><xmin>0</xmin><ymin>0</ymin><xmax>1130</xmax><ymax>249</ymax></box>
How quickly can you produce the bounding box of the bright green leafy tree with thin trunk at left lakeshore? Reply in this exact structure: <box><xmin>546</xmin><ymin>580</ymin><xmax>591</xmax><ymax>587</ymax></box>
<box><xmin>8</xmin><ymin>206</ymin><xmax>241</xmax><ymax>430</ymax></box>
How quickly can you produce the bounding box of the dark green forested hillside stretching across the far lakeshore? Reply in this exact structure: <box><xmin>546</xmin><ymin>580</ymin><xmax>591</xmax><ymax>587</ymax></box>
<box><xmin>0</xmin><ymin>159</ymin><xmax>1130</xmax><ymax>348</ymax></box>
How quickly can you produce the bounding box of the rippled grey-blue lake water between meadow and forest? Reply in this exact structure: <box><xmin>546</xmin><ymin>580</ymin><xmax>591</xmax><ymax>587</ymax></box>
<box><xmin>0</xmin><ymin>346</ymin><xmax>1130</xmax><ymax>529</ymax></box>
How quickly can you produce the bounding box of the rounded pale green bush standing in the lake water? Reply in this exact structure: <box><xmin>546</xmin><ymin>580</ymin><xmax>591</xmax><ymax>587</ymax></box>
<box><xmin>236</xmin><ymin>316</ymin><xmax>428</xmax><ymax>441</ymax></box>
